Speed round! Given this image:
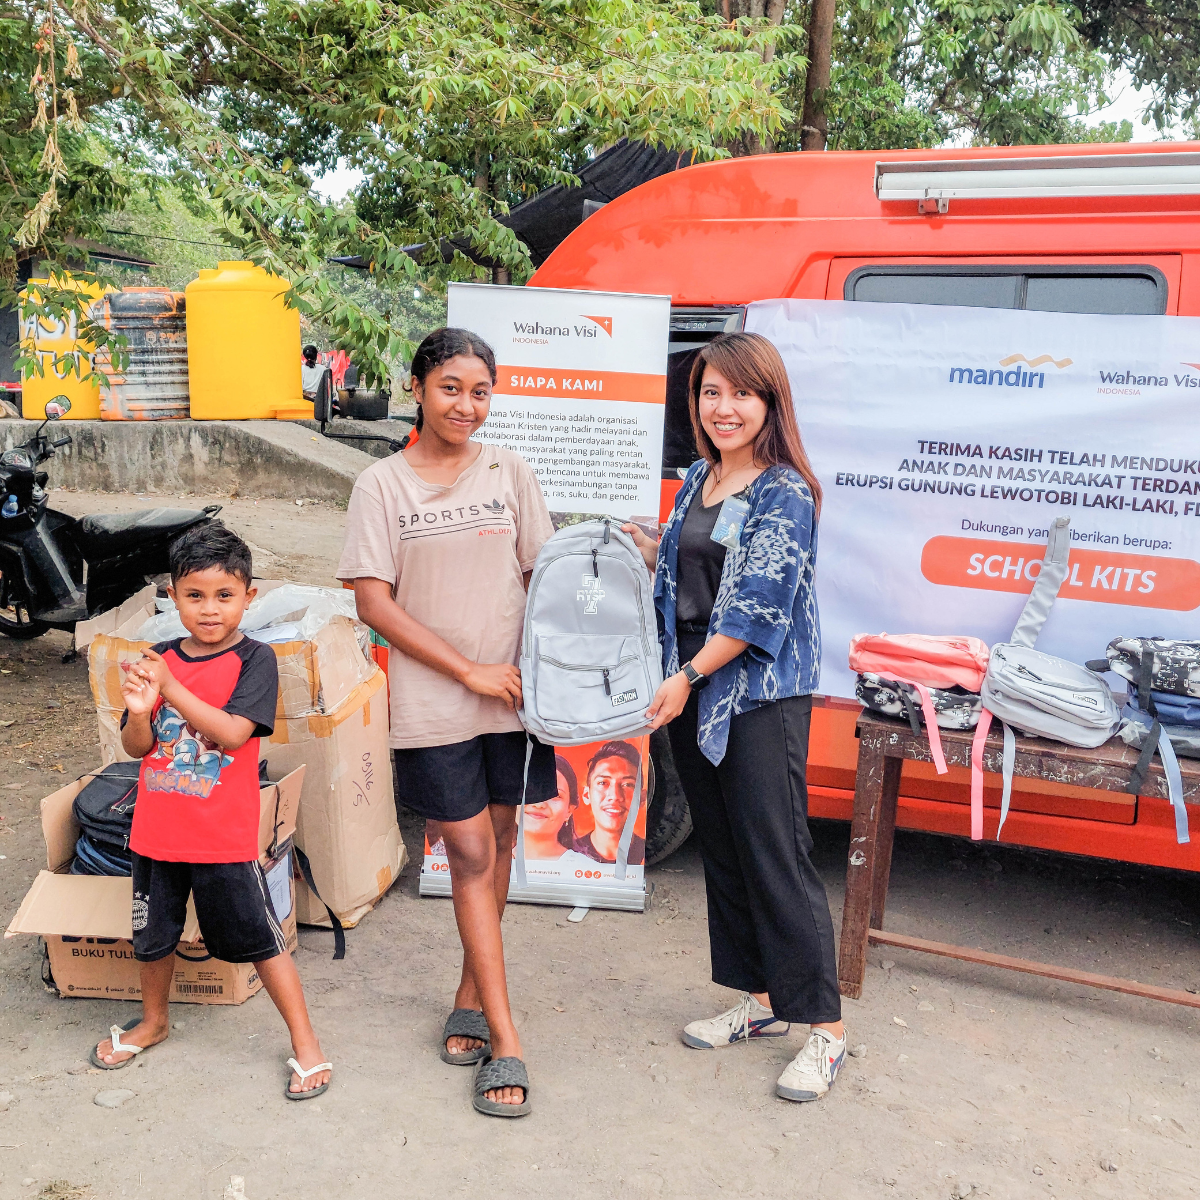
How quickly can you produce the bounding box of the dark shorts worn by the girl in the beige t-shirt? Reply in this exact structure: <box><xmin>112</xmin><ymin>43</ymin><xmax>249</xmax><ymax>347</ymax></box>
<box><xmin>392</xmin><ymin>731</ymin><xmax>558</xmax><ymax>821</ymax></box>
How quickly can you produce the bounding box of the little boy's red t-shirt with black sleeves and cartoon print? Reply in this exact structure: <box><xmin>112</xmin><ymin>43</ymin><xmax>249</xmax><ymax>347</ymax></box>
<box><xmin>121</xmin><ymin>637</ymin><xmax>280</xmax><ymax>863</ymax></box>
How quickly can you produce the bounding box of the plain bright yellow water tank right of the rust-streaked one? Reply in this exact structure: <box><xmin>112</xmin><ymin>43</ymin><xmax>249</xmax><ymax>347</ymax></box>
<box><xmin>184</xmin><ymin>263</ymin><xmax>312</xmax><ymax>421</ymax></box>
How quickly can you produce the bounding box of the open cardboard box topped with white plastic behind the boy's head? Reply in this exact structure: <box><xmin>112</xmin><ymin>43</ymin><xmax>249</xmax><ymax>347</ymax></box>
<box><xmin>76</xmin><ymin>580</ymin><xmax>376</xmax><ymax>764</ymax></box>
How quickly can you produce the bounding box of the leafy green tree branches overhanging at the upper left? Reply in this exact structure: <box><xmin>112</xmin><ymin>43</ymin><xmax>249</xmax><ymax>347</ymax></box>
<box><xmin>7</xmin><ymin>0</ymin><xmax>797</xmax><ymax>379</ymax></box>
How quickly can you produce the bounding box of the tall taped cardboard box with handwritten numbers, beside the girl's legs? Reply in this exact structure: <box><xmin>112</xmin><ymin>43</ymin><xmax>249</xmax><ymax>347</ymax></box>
<box><xmin>263</xmin><ymin>670</ymin><xmax>408</xmax><ymax>928</ymax></box>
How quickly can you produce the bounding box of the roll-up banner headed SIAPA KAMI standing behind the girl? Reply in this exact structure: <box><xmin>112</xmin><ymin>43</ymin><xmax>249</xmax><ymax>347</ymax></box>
<box><xmin>420</xmin><ymin>283</ymin><xmax>671</xmax><ymax>910</ymax></box>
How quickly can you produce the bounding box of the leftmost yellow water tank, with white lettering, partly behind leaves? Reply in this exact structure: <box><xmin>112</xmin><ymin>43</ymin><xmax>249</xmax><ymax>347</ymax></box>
<box><xmin>20</xmin><ymin>275</ymin><xmax>102</xmax><ymax>421</ymax></box>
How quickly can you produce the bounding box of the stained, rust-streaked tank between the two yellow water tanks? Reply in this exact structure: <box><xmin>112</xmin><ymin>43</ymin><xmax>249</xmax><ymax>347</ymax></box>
<box><xmin>96</xmin><ymin>288</ymin><xmax>188</xmax><ymax>421</ymax></box>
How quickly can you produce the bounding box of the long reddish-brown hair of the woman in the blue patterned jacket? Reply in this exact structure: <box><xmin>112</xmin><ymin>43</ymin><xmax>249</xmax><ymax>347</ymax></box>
<box><xmin>688</xmin><ymin>334</ymin><xmax>821</xmax><ymax>517</ymax></box>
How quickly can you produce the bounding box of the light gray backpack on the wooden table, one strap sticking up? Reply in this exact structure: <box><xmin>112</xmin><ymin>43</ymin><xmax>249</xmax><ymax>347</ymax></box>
<box><xmin>982</xmin><ymin>517</ymin><xmax>1121</xmax><ymax>839</ymax></box>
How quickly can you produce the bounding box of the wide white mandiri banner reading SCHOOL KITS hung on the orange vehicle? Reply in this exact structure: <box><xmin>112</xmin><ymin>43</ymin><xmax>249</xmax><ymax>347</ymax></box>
<box><xmin>746</xmin><ymin>300</ymin><xmax>1200</xmax><ymax>696</ymax></box>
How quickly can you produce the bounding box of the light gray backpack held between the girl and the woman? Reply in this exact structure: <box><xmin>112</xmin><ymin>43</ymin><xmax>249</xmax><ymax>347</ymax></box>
<box><xmin>516</xmin><ymin>517</ymin><xmax>662</xmax><ymax>887</ymax></box>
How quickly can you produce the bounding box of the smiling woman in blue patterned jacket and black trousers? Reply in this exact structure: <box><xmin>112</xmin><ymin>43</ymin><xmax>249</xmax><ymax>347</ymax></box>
<box><xmin>625</xmin><ymin>334</ymin><xmax>846</xmax><ymax>1100</ymax></box>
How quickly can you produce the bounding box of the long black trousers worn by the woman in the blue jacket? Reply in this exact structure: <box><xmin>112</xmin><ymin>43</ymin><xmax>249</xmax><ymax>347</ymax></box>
<box><xmin>667</xmin><ymin>635</ymin><xmax>841</xmax><ymax>1024</ymax></box>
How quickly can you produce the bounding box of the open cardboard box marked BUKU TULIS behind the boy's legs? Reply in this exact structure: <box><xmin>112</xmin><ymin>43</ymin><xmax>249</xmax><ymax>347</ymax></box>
<box><xmin>5</xmin><ymin>768</ymin><xmax>304</xmax><ymax>1004</ymax></box>
